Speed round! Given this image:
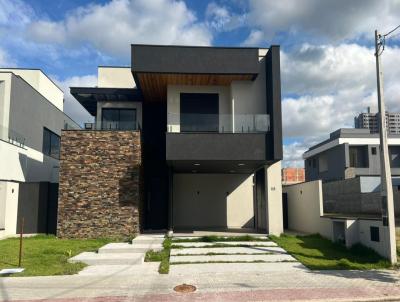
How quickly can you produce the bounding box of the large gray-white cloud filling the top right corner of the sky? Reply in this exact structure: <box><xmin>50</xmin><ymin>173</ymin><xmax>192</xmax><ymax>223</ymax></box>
<box><xmin>248</xmin><ymin>0</ymin><xmax>400</xmax><ymax>41</ymax></box>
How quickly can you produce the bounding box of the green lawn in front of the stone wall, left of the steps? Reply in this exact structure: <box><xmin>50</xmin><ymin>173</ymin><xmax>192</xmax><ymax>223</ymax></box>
<box><xmin>0</xmin><ymin>235</ymin><xmax>111</xmax><ymax>276</ymax></box>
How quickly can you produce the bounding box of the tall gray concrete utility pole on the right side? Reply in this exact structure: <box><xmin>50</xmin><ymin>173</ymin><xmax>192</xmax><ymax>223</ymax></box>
<box><xmin>375</xmin><ymin>30</ymin><xmax>397</xmax><ymax>264</ymax></box>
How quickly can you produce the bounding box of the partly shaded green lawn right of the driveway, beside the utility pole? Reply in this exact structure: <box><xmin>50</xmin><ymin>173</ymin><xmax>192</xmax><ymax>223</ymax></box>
<box><xmin>270</xmin><ymin>235</ymin><xmax>390</xmax><ymax>270</ymax></box>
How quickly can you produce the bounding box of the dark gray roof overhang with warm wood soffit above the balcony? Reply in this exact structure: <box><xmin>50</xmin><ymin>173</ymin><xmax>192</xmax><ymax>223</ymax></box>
<box><xmin>132</xmin><ymin>45</ymin><xmax>259</xmax><ymax>101</ymax></box>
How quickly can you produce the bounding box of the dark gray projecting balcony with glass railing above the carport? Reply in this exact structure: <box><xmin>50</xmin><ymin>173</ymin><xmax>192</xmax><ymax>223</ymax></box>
<box><xmin>166</xmin><ymin>114</ymin><xmax>270</xmax><ymax>173</ymax></box>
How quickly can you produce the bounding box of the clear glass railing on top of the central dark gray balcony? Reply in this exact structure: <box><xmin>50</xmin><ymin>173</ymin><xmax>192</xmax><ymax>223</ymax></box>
<box><xmin>167</xmin><ymin>113</ymin><xmax>270</xmax><ymax>133</ymax></box>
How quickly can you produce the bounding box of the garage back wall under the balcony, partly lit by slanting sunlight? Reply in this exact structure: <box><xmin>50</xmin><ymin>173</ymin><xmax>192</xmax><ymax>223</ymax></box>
<box><xmin>173</xmin><ymin>173</ymin><xmax>254</xmax><ymax>229</ymax></box>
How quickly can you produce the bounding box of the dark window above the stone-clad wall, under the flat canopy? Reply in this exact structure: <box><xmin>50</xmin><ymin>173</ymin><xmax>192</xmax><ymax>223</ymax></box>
<box><xmin>101</xmin><ymin>108</ymin><xmax>136</xmax><ymax>130</ymax></box>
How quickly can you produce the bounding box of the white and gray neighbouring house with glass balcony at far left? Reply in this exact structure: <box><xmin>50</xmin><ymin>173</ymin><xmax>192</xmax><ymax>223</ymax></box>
<box><xmin>0</xmin><ymin>68</ymin><xmax>79</xmax><ymax>238</ymax></box>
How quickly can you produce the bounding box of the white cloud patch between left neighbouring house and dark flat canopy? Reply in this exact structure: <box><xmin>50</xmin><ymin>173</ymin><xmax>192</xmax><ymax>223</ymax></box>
<box><xmin>53</xmin><ymin>75</ymin><xmax>97</xmax><ymax>125</ymax></box>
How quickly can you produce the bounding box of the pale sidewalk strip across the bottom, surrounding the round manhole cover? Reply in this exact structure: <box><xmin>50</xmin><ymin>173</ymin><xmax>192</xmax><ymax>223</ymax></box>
<box><xmin>0</xmin><ymin>270</ymin><xmax>400</xmax><ymax>302</ymax></box>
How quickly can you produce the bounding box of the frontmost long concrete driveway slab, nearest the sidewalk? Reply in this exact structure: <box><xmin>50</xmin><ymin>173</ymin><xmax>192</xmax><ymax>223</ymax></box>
<box><xmin>169</xmin><ymin>254</ymin><xmax>296</xmax><ymax>264</ymax></box>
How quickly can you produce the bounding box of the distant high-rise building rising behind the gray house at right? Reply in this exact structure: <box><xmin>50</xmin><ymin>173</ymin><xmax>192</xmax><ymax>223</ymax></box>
<box><xmin>354</xmin><ymin>107</ymin><xmax>400</xmax><ymax>134</ymax></box>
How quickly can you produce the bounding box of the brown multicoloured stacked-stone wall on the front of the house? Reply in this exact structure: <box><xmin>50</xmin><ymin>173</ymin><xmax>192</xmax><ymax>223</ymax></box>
<box><xmin>57</xmin><ymin>130</ymin><xmax>142</xmax><ymax>238</ymax></box>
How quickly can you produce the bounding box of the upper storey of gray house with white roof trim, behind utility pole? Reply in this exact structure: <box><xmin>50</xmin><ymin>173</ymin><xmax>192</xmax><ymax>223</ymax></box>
<box><xmin>303</xmin><ymin>129</ymin><xmax>400</xmax><ymax>182</ymax></box>
